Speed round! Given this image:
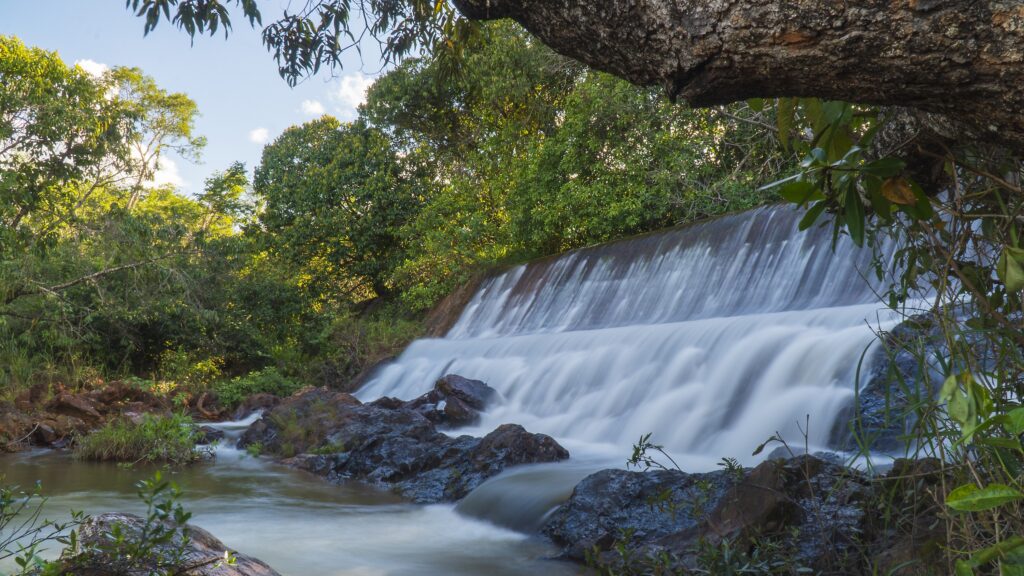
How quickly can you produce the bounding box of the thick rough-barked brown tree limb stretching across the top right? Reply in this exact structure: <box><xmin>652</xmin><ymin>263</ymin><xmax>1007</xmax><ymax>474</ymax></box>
<box><xmin>455</xmin><ymin>0</ymin><xmax>1024</xmax><ymax>151</ymax></box>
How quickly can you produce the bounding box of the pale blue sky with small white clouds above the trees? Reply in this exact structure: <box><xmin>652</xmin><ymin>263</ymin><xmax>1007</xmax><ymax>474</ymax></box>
<box><xmin>0</xmin><ymin>0</ymin><xmax>381</xmax><ymax>195</ymax></box>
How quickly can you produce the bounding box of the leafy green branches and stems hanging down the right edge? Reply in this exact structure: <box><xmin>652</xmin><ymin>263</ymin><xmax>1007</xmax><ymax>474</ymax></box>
<box><xmin>772</xmin><ymin>99</ymin><xmax>1024</xmax><ymax>574</ymax></box>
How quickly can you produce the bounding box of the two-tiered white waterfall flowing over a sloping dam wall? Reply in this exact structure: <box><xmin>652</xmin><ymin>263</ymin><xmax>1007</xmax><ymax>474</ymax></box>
<box><xmin>358</xmin><ymin>207</ymin><xmax>897</xmax><ymax>468</ymax></box>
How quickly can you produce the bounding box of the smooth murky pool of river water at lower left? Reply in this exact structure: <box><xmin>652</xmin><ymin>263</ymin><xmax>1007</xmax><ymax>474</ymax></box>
<box><xmin>0</xmin><ymin>436</ymin><xmax>581</xmax><ymax>576</ymax></box>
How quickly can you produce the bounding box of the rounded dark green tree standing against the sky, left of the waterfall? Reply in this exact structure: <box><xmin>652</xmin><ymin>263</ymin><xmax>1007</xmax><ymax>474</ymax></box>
<box><xmin>253</xmin><ymin>116</ymin><xmax>420</xmax><ymax>297</ymax></box>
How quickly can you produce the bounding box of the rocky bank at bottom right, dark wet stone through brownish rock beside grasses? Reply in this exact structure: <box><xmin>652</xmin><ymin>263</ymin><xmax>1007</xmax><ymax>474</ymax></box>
<box><xmin>542</xmin><ymin>455</ymin><xmax>944</xmax><ymax>575</ymax></box>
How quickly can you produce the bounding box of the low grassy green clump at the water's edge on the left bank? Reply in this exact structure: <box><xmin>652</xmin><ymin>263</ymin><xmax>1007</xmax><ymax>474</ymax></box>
<box><xmin>75</xmin><ymin>414</ymin><xmax>210</xmax><ymax>464</ymax></box>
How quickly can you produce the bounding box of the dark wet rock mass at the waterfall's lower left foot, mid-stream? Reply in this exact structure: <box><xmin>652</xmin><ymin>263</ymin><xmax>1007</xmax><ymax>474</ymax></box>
<box><xmin>239</xmin><ymin>388</ymin><xmax>568</xmax><ymax>503</ymax></box>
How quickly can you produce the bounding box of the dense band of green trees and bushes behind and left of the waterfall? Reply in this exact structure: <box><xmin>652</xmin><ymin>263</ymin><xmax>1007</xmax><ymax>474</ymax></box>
<box><xmin>0</xmin><ymin>25</ymin><xmax>783</xmax><ymax>405</ymax></box>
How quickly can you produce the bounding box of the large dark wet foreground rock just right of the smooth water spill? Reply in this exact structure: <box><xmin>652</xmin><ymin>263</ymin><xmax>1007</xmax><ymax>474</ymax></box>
<box><xmin>543</xmin><ymin>456</ymin><xmax>867</xmax><ymax>573</ymax></box>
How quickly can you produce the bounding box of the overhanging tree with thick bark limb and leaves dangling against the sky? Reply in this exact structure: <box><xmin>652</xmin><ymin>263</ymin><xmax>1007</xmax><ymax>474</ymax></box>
<box><xmin>128</xmin><ymin>0</ymin><xmax>1024</xmax><ymax>150</ymax></box>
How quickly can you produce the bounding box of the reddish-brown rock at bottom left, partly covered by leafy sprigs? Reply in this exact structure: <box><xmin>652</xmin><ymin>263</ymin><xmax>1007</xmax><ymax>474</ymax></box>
<box><xmin>66</xmin><ymin>513</ymin><xmax>281</xmax><ymax>576</ymax></box>
